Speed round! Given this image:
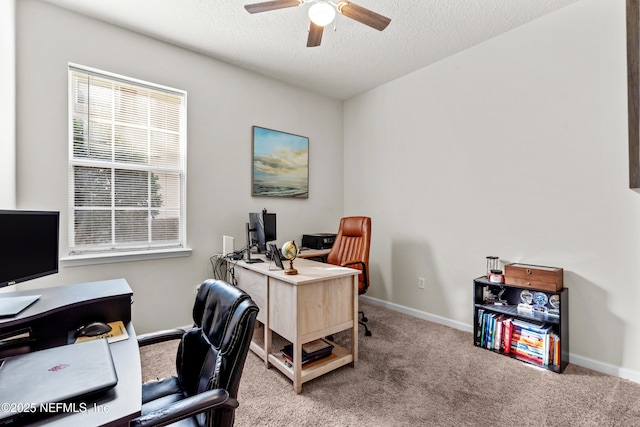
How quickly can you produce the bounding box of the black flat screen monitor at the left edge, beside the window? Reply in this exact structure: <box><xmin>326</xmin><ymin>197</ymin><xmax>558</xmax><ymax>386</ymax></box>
<box><xmin>0</xmin><ymin>210</ymin><xmax>60</xmax><ymax>287</ymax></box>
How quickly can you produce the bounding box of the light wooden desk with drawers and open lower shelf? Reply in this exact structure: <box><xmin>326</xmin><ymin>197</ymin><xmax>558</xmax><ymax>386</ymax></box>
<box><xmin>234</xmin><ymin>259</ymin><xmax>360</xmax><ymax>393</ymax></box>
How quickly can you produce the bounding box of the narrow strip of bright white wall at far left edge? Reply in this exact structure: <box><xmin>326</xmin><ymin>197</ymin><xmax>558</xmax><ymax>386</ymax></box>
<box><xmin>0</xmin><ymin>0</ymin><xmax>16</xmax><ymax>209</ymax></box>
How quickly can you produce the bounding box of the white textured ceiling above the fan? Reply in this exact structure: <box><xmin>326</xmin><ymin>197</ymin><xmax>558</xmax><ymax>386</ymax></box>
<box><xmin>38</xmin><ymin>0</ymin><xmax>579</xmax><ymax>99</ymax></box>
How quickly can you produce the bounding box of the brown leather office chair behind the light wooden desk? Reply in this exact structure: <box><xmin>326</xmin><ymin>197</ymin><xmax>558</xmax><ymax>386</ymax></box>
<box><xmin>327</xmin><ymin>216</ymin><xmax>371</xmax><ymax>336</ymax></box>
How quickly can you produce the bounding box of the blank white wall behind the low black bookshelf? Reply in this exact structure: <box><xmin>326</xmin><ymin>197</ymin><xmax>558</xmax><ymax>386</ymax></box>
<box><xmin>344</xmin><ymin>0</ymin><xmax>640</xmax><ymax>381</ymax></box>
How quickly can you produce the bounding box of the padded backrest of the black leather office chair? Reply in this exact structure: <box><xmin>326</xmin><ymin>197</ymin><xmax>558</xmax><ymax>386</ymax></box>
<box><xmin>176</xmin><ymin>280</ymin><xmax>258</xmax><ymax>426</ymax></box>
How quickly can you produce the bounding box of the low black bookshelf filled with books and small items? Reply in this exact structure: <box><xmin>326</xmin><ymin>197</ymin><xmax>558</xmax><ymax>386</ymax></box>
<box><xmin>473</xmin><ymin>276</ymin><xmax>569</xmax><ymax>373</ymax></box>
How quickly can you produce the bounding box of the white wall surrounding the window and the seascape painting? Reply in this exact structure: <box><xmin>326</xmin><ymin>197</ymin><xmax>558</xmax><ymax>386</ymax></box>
<box><xmin>17</xmin><ymin>0</ymin><xmax>343</xmax><ymax>332</ymax></box>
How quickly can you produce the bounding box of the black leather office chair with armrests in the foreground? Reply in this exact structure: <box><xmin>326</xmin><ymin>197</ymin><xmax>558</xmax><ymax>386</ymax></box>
<box><xmin>129</xmin><ymin>280</ymin><xmax>258</xmax><ymax>427</ymax></box>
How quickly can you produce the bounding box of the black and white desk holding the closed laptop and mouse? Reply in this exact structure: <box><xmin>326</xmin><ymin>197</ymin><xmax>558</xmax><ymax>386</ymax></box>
<box><xmin>0</xmin><ymin>279</ymin><xmax>142</xmax><ymax>427</ymax></box>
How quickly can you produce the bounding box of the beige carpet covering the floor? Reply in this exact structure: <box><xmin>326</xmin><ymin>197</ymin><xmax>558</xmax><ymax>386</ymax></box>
<box><xmin>142</xmin><ymin>301</ymin><xmax>640</xmax><ymax>427</ymax></box>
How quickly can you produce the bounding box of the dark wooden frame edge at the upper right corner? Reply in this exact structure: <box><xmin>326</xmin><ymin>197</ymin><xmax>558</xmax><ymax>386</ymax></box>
<box><xmin>627</xmin><ymin>0</ymin><xmax>640</xmax><ymax>188</ymax></box>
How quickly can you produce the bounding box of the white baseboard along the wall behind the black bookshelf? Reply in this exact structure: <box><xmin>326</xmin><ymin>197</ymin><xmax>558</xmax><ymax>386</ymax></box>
<box><xmin>360</xmin><ymin>295</ymin><xmax>640</xmax><ymax>384</ymax></box>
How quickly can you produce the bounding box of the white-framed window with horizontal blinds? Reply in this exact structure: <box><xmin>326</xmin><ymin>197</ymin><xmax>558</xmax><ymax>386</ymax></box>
<box><xmin>69</xmin><ymin>65</ymin><xmax>187</xmax><ymax>255</ymax></box>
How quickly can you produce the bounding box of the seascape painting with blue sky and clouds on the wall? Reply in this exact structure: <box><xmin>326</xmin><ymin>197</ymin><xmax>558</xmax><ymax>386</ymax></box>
<box><xmin>251</xmin><ymin>126</ymin><xmax>309</xmax><ymax>199</ymax></box>
